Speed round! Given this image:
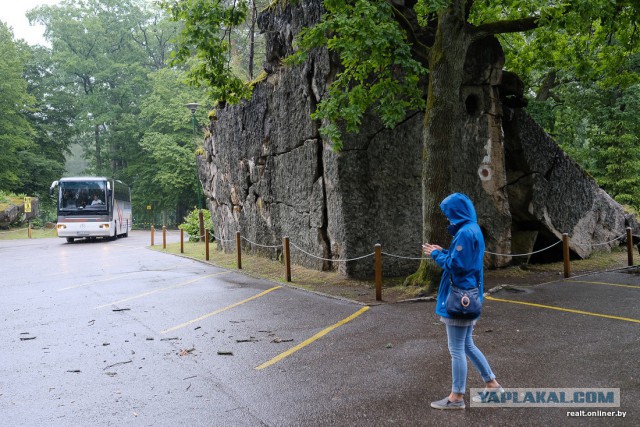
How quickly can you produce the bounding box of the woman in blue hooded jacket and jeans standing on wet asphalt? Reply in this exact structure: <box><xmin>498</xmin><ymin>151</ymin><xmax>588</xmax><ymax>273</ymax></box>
<box><xmin>422</xmin><ymin>193</ymin><xmax>502</xmax><ymax>409</ymax></box>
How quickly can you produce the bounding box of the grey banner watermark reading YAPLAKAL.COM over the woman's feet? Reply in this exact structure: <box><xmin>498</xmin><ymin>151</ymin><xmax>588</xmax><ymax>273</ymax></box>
<box><xmin>470</xmin><ymin>388</ymin><xmax>620</xmax><ymax>412</ymax></box>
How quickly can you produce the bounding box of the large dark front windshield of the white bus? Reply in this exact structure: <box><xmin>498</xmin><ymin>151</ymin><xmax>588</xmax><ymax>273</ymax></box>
<box><xmin>58</xmin><ymin>181</ymin><xmax>109</xmax><ymax>213</ymax></box>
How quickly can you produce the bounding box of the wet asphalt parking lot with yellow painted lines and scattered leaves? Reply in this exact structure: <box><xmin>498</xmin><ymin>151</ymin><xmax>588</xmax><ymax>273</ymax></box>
<box><xmin>0</xmin><ymin>232</ymin><xmax>640</xmax><ymax>426</ymax></box>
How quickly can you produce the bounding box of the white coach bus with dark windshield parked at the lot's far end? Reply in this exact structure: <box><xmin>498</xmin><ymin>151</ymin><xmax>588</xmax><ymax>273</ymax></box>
<box><xmin>49</xmin><ymin>177</ymin><xmax>133</xmax><ymax>243</ymax></box>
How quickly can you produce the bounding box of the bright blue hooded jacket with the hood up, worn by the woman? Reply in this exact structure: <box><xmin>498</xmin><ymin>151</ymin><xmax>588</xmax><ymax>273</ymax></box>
<box><xmin>431</xmin><ymin>193</ymin><xmax>484</xmax><ymax>318</ymax></box>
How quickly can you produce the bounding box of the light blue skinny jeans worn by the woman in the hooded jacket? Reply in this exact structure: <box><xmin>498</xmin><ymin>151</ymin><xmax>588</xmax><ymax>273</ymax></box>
<box><xmin>446</xmin><ymin>325</ymin><xmax>496</xmax><ymax>394</ymax></box>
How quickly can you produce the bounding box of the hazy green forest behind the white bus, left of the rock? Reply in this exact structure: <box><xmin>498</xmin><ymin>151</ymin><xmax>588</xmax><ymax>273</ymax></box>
<box><xmin>0</xmin><ymin>0</ymin><xmax>266</xmax><ymax>225</ymax></box>
